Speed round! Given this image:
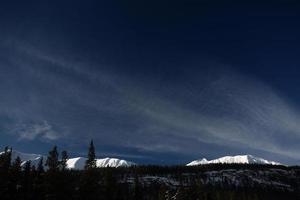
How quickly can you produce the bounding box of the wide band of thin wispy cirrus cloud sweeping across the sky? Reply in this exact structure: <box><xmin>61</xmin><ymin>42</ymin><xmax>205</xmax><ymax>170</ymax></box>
<box><xmin>2</xmin><ymin>41</ymin><xmax>300</xmax><ymax>162</ymax></box>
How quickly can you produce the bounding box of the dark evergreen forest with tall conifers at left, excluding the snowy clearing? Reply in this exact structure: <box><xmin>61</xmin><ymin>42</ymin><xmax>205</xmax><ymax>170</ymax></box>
<box><xmin>0</xmin><ymin>141</ymin><xmax>300</xmax><ymax>200</ymax></box>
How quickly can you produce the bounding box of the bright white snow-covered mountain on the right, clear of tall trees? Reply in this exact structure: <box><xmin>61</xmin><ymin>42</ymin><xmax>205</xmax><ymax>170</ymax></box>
<box><xmin>187</xmin><ymin>155</ymin><xmax>282</xmax><ymax>166</ymax></box>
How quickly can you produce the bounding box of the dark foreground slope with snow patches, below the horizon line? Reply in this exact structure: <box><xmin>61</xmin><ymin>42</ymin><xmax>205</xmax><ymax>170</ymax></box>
<box><xmin>0</xmin><ymin>160</ymin><xmax>300</xmax><ymax>200</ymax></box>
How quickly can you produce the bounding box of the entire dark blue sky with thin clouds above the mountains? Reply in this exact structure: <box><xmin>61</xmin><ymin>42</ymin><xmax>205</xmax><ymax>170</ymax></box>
<box><xmin>0</xmin><ymin>0</ymin><xmax>300</xmax><ymax>164</ymax></box>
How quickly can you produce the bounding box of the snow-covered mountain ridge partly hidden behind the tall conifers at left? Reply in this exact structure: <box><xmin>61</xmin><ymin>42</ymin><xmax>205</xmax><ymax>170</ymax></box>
<box><xmin>0</xmin><ymin>150</ymin><xmax>135</xmax><ymax>169</ymax></box>
